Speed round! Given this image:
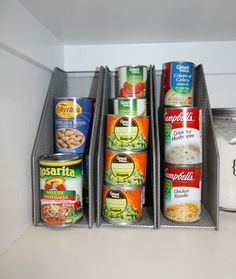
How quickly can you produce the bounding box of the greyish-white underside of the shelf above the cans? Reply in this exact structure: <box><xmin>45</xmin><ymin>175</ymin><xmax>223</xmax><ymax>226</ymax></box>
<box><xmin>19</xmin><ymin>0</ymin><xmax>236</xmax><ymax>45</ymax></box>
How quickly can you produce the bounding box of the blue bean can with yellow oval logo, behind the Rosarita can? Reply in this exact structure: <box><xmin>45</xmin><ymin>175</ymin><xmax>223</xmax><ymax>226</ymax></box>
<box><xmin>54</xmin><ymin>97</ymin><xmax>94</xmax><ymax>154</ymax></box>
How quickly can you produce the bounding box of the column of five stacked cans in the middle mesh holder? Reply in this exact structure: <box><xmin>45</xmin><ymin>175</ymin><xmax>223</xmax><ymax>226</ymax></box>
<box><xmin>102</xmin><ymin>66</ymin><xmax>149</xmax><ymax>225</ymax></box>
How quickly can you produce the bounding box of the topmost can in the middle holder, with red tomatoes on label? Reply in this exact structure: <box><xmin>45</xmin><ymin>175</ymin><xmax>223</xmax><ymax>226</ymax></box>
<box><xmin>118</xmin><ymin>65</ymin><xmax>147</xmax><ymax>97</ymax></box>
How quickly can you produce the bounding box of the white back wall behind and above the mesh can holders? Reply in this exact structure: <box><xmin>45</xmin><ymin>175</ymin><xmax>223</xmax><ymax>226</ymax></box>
<box><xmin>64</xmin><ymin>41</ymin><xmax>236</xmax><ymax>107</ymax></box>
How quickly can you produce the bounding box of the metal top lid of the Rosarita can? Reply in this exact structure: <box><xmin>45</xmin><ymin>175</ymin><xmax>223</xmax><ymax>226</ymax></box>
<box><xmin>39</xmin><ymin>153</ymin><xmax>82</xmax><ymax>164</ymax></box>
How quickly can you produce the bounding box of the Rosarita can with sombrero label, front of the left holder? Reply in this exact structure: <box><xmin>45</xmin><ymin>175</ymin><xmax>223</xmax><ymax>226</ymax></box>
<box><xmin>39</xmin><ymin>153</ymin><xmax>83</xmax><ymax>226</ymax></box>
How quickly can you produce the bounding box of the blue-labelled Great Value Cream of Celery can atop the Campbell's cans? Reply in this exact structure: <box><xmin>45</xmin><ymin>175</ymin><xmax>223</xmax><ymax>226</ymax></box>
<box><xmin>163</xmin><ymin>61</ymin><xmax>195</xmax><ymax>107</ymax></box>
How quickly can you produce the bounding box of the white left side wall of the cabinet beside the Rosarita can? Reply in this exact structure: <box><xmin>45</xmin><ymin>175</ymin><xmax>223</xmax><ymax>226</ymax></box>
<box><xmin>0</xmin><ymin>49</ymin><xmax>51</xmax><ymax>255</ymax></box>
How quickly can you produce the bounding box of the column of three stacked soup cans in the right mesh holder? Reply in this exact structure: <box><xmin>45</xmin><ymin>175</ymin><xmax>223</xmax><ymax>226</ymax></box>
<box><xmin>163</xmin><ymin>62</ymin><xmax>202</xmax><ymax>222</ymax></box>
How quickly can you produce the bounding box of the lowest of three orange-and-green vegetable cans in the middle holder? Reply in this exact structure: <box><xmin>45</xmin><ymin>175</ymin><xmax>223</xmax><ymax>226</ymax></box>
<box><xmin>102</xmin><ymin>185</ymin><xmax>143</xmax><ymax>225</ymax></box>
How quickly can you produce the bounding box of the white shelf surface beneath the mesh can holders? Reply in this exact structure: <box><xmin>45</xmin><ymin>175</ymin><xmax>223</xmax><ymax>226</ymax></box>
<box><xmin>0</xmin><ymin>212</ymin><xmax>236</xmax><ymax>279</ymax></box>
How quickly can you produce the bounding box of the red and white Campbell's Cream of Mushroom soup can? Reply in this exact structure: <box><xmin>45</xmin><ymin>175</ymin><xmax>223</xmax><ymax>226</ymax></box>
<box><xmin>164</xmin><ymin>107</ymin><xmax>202</xmax><ymax>164</ymax></box>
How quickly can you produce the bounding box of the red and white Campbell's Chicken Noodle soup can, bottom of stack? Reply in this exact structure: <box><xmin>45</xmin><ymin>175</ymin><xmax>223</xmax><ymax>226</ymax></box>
<box><xmin>164</xmin><ymin>164</ymin><xmax>202</xmax><ymax>223</ymax></box>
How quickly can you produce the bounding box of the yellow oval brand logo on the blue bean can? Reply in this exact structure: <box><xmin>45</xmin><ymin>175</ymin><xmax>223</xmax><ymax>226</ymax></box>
<box><xmin>55</xmin><ymin>101</ymin><xmax>82</xmax><ymax>119</ymax></box>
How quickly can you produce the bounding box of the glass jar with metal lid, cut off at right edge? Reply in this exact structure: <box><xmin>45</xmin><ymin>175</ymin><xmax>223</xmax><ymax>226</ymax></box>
<box><xmin>212</xmin><ymin>108</ymin><xmax>236</xmax><ymax>211</ymax></box>
